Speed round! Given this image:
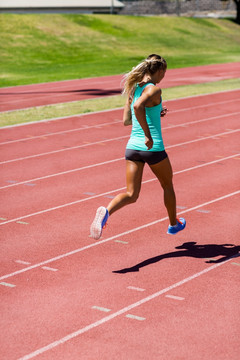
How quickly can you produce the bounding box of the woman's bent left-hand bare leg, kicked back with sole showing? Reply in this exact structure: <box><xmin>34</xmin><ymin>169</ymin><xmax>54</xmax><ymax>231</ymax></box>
<box><xmin>107</xmin><ymin>160</ymin><xmax>144</xmax><ymax>215</ymax></box>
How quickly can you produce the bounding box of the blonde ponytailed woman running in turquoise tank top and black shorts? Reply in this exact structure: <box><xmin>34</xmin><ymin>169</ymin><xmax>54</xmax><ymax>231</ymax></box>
<box><xmin>90</xmin><ymin>54</ymin><xmax>186</xmax><ymax>240</ymax></box>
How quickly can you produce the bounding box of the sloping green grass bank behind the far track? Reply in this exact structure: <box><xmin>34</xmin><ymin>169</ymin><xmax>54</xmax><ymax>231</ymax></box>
<box><xmin>0</xmin><ymin>14</ymin><xmax>240</xmax><ymax>87</ymax></box>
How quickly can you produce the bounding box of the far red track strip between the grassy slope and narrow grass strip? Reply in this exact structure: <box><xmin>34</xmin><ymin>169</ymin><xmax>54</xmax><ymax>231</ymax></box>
<box><xmin>0</xmin><ymin>62</ymin><xmax>240</xmax><ymax>111</ymax></box>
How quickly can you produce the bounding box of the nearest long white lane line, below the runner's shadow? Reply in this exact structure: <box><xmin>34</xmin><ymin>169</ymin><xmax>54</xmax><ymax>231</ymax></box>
<box><xmin>18</xmin><ymin>259</ymin><xmax>234</xmax><ymax>360</ymax></box>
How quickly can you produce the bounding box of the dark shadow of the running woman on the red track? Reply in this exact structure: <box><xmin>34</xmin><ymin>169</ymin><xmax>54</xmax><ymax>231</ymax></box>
<box><xmin>113</xmin><ymin>242</ymin><xmax>240</xmax><ymax>274</ymax></box>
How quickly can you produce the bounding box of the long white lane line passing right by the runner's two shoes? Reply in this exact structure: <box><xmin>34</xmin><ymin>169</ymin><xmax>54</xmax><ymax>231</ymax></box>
<box><xmin>0</xmin><ymin>190</ymin><xmax>240</xmax><ymax>280</ymax></box>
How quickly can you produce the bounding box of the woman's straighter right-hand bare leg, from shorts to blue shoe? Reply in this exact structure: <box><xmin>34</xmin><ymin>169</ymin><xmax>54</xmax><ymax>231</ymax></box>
<box><xmin>150</xmin><ymin>158</ymin><xmax>177</xmax><ymax>226</ymax></box>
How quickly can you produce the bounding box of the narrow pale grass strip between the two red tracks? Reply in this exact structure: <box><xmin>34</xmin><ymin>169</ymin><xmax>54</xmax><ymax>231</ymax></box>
<box><xmin>0</xmin><ymin>79</ymin><xmax>240</xmax><ymax>127</ymax></box>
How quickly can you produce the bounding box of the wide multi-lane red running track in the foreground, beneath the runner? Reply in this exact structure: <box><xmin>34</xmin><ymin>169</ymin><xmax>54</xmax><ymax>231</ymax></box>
<box><xmin>0</xmin><ymin>91</ymin><xmax>240</xmax><ymax>360</ymax></box>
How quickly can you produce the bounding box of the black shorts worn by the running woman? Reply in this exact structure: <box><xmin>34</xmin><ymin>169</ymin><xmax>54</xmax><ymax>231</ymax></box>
<box><xmin>125</xmin><ymin>149</ymin><xmax>167</xmax><ymax>165</ymax></box>
